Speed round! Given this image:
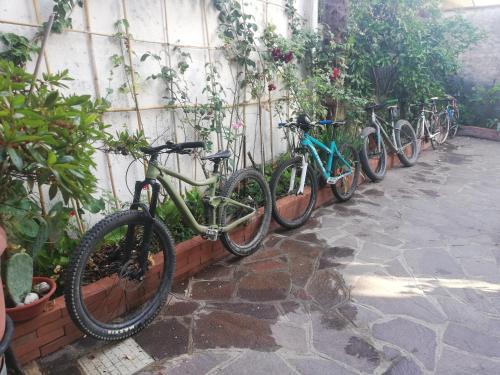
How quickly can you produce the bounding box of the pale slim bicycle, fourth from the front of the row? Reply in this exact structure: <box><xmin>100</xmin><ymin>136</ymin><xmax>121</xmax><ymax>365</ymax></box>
<box><xmin>409</xmin><ymin>98</ymin><xmax>449</xmax><ymax>149</ymax></box>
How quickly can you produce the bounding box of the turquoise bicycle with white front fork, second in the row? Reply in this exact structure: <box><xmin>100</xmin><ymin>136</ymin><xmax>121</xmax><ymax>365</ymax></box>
<box><xmin>270</xmin><ymin>116</ymin><xmax>360</xmax><ymax>229</ymax></box>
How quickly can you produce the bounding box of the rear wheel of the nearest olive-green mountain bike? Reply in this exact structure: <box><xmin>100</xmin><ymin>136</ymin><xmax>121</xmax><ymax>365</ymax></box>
<box><xmin>220</xmin><ymin>168</ymin><xmax>272</xmax><ymax>256</ymax></box>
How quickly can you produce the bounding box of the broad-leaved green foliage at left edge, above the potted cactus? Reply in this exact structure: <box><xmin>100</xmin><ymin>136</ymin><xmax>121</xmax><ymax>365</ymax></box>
<box><xmin>0</xmin><ymin>61</ymin><xmax>108</xmax><ymax>206</ymax></box>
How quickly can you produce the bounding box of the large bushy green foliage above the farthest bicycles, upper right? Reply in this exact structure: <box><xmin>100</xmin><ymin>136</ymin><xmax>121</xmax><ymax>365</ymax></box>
<box><xmin>347</xmin><ymin>0</ymin><xmax>481</xmax><ymax>102</ymax></box>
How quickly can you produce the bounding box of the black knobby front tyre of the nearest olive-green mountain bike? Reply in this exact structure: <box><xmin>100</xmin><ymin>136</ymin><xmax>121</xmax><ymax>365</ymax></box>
<box><xmin>64</xmin><ymin>210</ymin><xmax>175</xmax><ymax>341</ymax></box>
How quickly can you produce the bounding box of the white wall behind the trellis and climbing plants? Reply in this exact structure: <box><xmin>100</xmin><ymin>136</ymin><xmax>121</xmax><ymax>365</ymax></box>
<box><xmin>0</xmin><ymin>0</ymin><xmax>318</xmax><ymax>212</ymax></box>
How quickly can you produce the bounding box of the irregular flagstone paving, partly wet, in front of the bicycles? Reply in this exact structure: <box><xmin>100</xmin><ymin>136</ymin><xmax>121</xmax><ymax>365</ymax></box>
<box><xmin>36</xmin><ymin>138</ymin><xmax>500</xmax><ymax>375</ymax></box>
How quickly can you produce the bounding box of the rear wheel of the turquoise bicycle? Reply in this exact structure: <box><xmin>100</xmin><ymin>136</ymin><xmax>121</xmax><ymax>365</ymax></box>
<box><xmin>331</xmin><ymin>144</ymin><xmax>361</xmax><ymax>202</ymax></box>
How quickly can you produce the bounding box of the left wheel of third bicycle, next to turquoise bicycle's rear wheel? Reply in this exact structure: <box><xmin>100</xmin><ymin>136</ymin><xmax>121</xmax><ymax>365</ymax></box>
<box><xmin>359</xmin><ymin>128</ymin><xmax>387</xmax><ymax>182</ymax></box>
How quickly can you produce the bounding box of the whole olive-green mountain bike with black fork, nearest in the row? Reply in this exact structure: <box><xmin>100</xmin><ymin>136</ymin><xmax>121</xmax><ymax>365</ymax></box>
<box><xmin>65</xmin><ymin>142</ymin><xmax>271</xmax><ymax>340</ymax></box>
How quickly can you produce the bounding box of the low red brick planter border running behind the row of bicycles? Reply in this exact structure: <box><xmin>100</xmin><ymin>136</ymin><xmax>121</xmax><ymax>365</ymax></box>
<box><xmin>12</xmin><ymin>141</ymin><xmax>428</xmax><ymax>364</ymax></box>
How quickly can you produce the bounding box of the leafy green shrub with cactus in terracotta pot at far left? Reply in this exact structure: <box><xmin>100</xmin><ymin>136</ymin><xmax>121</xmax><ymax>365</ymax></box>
<box><xmin>0</xmin><ymin>60</ymin><xmax>111</xmax><ymax>323</ymax></box>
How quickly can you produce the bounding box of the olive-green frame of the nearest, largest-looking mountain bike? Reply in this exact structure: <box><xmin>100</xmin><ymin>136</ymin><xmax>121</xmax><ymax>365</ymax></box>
<box><xmin>133</xmin><ymin>161</ymin><xmax>257</xmax><ymax>237</ymax></box>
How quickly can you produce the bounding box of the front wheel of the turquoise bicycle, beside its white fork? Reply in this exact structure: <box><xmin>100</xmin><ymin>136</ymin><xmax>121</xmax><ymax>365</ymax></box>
<box><xmin>270</xmin><ymin>156</ymin><xmax>318</xmax><ymax>229</ymax></box>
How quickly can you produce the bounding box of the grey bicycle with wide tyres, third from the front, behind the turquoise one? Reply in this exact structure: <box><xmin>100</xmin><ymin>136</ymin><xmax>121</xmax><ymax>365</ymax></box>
<box><xmin>360</xmin><ymin>100</ymin><xmax>418</xmax><ymax>182</ymax></box>
